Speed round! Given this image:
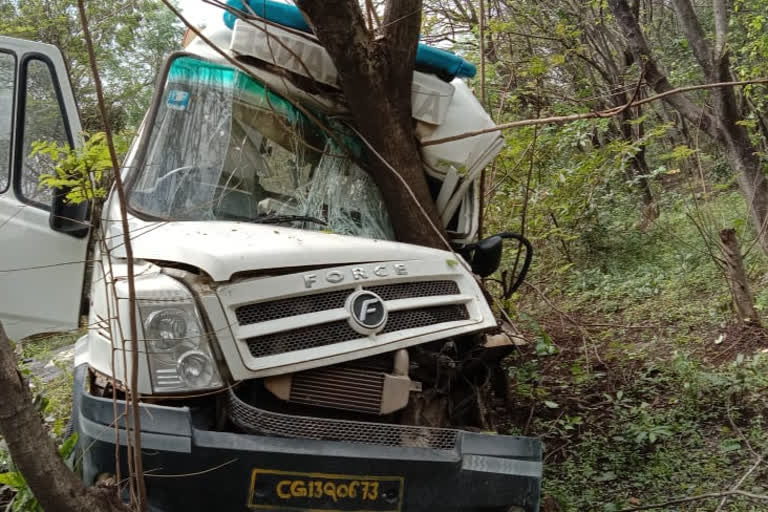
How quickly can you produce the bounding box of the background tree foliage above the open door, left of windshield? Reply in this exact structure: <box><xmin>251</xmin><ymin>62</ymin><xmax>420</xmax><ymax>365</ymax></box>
<box><xmin>0</xmin><ymin>0</ymin><xmax>183</xmax><ymax>131</ymax></box>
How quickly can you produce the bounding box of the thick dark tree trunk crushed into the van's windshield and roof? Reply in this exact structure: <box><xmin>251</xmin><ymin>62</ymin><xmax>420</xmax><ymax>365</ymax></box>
<box><xmin>296</xmin><ymin>0</ymin><xmax>445</xmax><ymax>248</ymax></box>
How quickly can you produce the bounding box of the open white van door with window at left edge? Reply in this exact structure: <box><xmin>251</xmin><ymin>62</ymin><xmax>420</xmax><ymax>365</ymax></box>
<box><xmin>0</xmin><ymin>37</ymin><xmax>88</xmax><ymax>340</ymax></box>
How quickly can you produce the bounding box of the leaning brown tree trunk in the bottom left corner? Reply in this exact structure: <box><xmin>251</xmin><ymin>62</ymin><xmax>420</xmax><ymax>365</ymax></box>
<box><xmin>0</xmin><ymin>323</ymin><xmax>126</xmax><ymax>512</ymax></box>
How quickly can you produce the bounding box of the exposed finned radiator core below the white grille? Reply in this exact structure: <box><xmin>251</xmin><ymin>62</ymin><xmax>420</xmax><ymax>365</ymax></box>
<box><xmin>290</xmin><ymin>366</ymin><xmax>384</xmax><ymax>414</ymax></box>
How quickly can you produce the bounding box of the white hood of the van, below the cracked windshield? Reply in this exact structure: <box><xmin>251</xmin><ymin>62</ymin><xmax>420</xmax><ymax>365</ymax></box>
<box><xmin>107</xmin><ymin>217</ymin><xmax>454</xmax><ymax>281</ymax></box>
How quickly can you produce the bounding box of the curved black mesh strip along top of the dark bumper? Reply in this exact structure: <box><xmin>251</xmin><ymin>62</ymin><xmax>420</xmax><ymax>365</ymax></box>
<box><xmin>227</xmin><ymin>389</ymin><xmax>459</xmax><ymax>450</ymax></box>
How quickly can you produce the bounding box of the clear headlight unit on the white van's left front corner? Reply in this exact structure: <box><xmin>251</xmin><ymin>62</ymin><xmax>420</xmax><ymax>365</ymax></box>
<box><xmin>136</xmin><ymin>275</ymin><xmax>222</xmax><ymax>392</ymax></box>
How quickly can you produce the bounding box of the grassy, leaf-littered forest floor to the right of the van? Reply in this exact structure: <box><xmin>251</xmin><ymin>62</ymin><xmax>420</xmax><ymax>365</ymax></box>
<box><xmin>504</xmin><ymin>190</ymin><xmax>768</xmax><ymax>511</ymax></box>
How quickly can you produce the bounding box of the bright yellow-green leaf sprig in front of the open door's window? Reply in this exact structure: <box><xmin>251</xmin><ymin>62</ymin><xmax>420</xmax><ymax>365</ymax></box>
<box><xmin>32</xmin><ymin>132</ymin><xmax>129</xmax><ymax>204</ymax></box>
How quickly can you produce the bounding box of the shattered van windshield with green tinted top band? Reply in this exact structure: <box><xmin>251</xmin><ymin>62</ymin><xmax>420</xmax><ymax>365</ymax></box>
<box><xmin>129</xmin><ymin>57</ymin><xmax>394</xmax><ymax>240</ymax></box>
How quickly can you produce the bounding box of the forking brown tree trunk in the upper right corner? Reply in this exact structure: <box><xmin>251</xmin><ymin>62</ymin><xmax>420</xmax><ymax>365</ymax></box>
<box><xmin>608</xmin><ymin>0</ymin><xmax>768</xmax><ymax>254</ymax></box>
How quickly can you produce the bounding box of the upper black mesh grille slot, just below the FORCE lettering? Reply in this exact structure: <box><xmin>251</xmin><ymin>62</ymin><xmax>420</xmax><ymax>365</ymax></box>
<box><xmin>235</xmin><ymin>281</ymin><xmax>460</xmax><ymax>325</ymax></box>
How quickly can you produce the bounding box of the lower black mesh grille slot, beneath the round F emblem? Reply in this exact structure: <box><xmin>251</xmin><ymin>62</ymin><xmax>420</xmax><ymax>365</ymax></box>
<box><xmin>245</xmin><ymin>304</ymin><xmax>469</xmax><ymax>357</ymax></box>
